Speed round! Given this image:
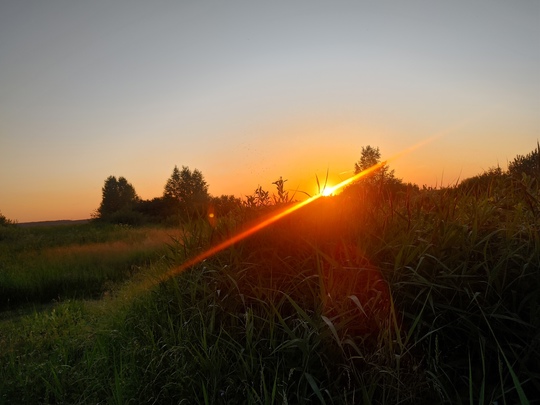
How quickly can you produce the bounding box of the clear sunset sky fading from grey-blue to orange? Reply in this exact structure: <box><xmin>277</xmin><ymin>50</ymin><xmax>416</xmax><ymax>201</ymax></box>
<box><xmin>0</xmin><ymin>0</ymin><xmax>540</xmax><ymax>222</ymax></box>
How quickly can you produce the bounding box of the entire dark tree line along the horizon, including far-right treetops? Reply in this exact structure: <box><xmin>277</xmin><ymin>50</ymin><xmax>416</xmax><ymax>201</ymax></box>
<box><xmin>89</xmin><ymin>141</ymin><xmax>540</xmax><ymax>225</ymax></box>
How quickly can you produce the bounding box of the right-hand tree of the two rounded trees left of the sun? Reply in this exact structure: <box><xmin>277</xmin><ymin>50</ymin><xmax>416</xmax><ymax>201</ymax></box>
<box><xmin>163</xmin><ymin>166</ymin><xmax>209</xmax><ymax>217</ymax></box>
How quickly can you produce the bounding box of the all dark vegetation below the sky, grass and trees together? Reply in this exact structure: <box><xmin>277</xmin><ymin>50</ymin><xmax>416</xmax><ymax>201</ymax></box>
<box><xmin>0</xmin><ymin>143</ymin><xmax>540</xmax><ymax>404</ymax></box>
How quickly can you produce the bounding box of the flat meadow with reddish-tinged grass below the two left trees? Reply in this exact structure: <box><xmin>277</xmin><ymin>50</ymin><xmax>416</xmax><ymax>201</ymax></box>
<box><xmin>0</xmin><ymin>225</ymin><xmax>178</xmax><ymax>308</ymax></box>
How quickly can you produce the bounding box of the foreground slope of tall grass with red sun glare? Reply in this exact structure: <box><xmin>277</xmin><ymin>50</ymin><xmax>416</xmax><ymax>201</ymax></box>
<box><xmin>0</xmin><ymin>181</ymin><xmax>540</xmax><ymax>404</ymax></box>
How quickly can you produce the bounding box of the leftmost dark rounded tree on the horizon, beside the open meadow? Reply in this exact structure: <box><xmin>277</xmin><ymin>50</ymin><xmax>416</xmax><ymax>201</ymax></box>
<box><xmin>98</xmin><ymin>176</ymin><xmax>139</xmax><ymax>218</ymax></box>
